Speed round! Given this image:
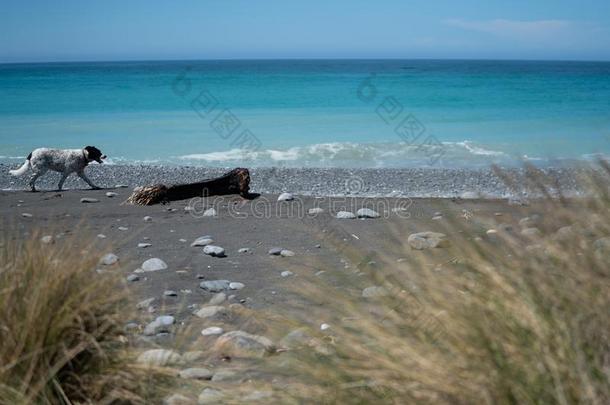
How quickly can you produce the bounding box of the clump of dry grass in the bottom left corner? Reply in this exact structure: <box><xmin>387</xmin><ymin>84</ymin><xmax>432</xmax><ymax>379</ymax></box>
<box><xmin>0</xmin><ymin>235</ymin><xmax>165</xmax><ymax>404</ymax></box>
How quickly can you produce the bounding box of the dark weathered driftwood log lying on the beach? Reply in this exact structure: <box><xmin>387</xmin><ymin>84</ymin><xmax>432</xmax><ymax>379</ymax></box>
<box><xmin>127</xmin><ymin>168</ymin><xmax>250</xmax><ymax>205</ymax></box>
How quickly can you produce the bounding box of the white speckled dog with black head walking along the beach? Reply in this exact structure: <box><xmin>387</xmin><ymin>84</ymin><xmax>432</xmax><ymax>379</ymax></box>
<box><xmin>9</xmin><ymin>146</ymin><xmax>106</xmax><ymax>191</ymax></box>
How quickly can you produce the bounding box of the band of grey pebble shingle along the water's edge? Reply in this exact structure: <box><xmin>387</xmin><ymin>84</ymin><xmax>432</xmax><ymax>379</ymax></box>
<box><xmin>0</xmin><ymin>163</ymin><xmax>594</xmax><ymax>199</ymax></box>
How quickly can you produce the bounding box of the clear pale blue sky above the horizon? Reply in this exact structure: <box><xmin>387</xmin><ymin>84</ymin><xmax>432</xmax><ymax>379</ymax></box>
<box><xmin>0</xmin><ymin>0</ymin><xmax>610</xmax><ymax>62</ymax></box>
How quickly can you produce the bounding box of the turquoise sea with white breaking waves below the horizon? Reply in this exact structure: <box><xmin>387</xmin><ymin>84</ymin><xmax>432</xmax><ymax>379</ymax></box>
<box><xmin>0</xmin><ymin>60</ymin><xmax>610</xmax><ymax>168</ymax></box>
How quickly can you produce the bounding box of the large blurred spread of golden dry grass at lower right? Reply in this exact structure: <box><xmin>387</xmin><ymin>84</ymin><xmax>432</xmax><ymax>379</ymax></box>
<box><xmin>270</xmin><ymin>165</ymin><xmax>610</xmax><ymax>404</ymax></box>
